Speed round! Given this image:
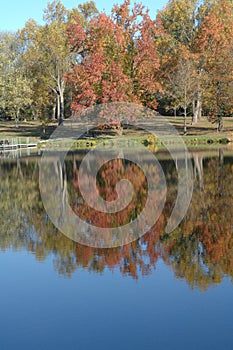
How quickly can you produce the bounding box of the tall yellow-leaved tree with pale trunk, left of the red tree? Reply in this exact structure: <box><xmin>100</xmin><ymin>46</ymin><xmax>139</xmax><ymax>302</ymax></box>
<box><xmin>21</xmin><ymin>0</ymin><xmax>70</xmax><ymax>123</ymax></box>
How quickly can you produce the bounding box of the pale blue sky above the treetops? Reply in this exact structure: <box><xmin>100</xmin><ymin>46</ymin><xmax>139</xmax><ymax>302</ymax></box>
<box><xmin>0</xmin><ymin>0</ymin><xmax>167</xmax><ymax>31</ymax></box>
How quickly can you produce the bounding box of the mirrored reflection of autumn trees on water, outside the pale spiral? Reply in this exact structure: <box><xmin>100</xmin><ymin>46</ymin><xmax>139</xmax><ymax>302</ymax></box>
<box><xmin>0</xmin><ymin>150</ymin><xmax>233</xmax><ymax>290</ymax></box>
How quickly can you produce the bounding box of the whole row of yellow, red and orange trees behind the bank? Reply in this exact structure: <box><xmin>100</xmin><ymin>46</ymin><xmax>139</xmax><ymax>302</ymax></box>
<box><xmin>0</xmin><ymin>0</ymin><xmax>233</xmax><ymax>123</ymax></box>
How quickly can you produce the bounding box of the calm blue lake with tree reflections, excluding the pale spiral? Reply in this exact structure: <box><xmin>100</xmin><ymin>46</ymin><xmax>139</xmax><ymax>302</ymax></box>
<box><xmin>0</xmin><ymin>147</ymin><xmax>233</xmax><ymax>350</ymax></box>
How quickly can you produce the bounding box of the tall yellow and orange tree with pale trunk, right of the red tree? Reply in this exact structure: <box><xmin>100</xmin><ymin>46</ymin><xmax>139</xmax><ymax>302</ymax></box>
<box><xmin>157</xmin><ymin>0</ymin><xmax>213</xmax><ymax>123</ymax></box>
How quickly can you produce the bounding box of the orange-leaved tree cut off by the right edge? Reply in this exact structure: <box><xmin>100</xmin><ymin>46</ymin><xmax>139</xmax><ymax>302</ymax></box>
<box><xmin>196</xmin><ymin>0</ymin><xmax>233</xmax><ymax>130</ymax></box>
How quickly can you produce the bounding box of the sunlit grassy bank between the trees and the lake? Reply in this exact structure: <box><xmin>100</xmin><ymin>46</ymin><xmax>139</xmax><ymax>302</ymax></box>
<box><xmin>0</xmin><ymin>117</ymin><xmax>233</xmax><ymax>148</ymax></box>
